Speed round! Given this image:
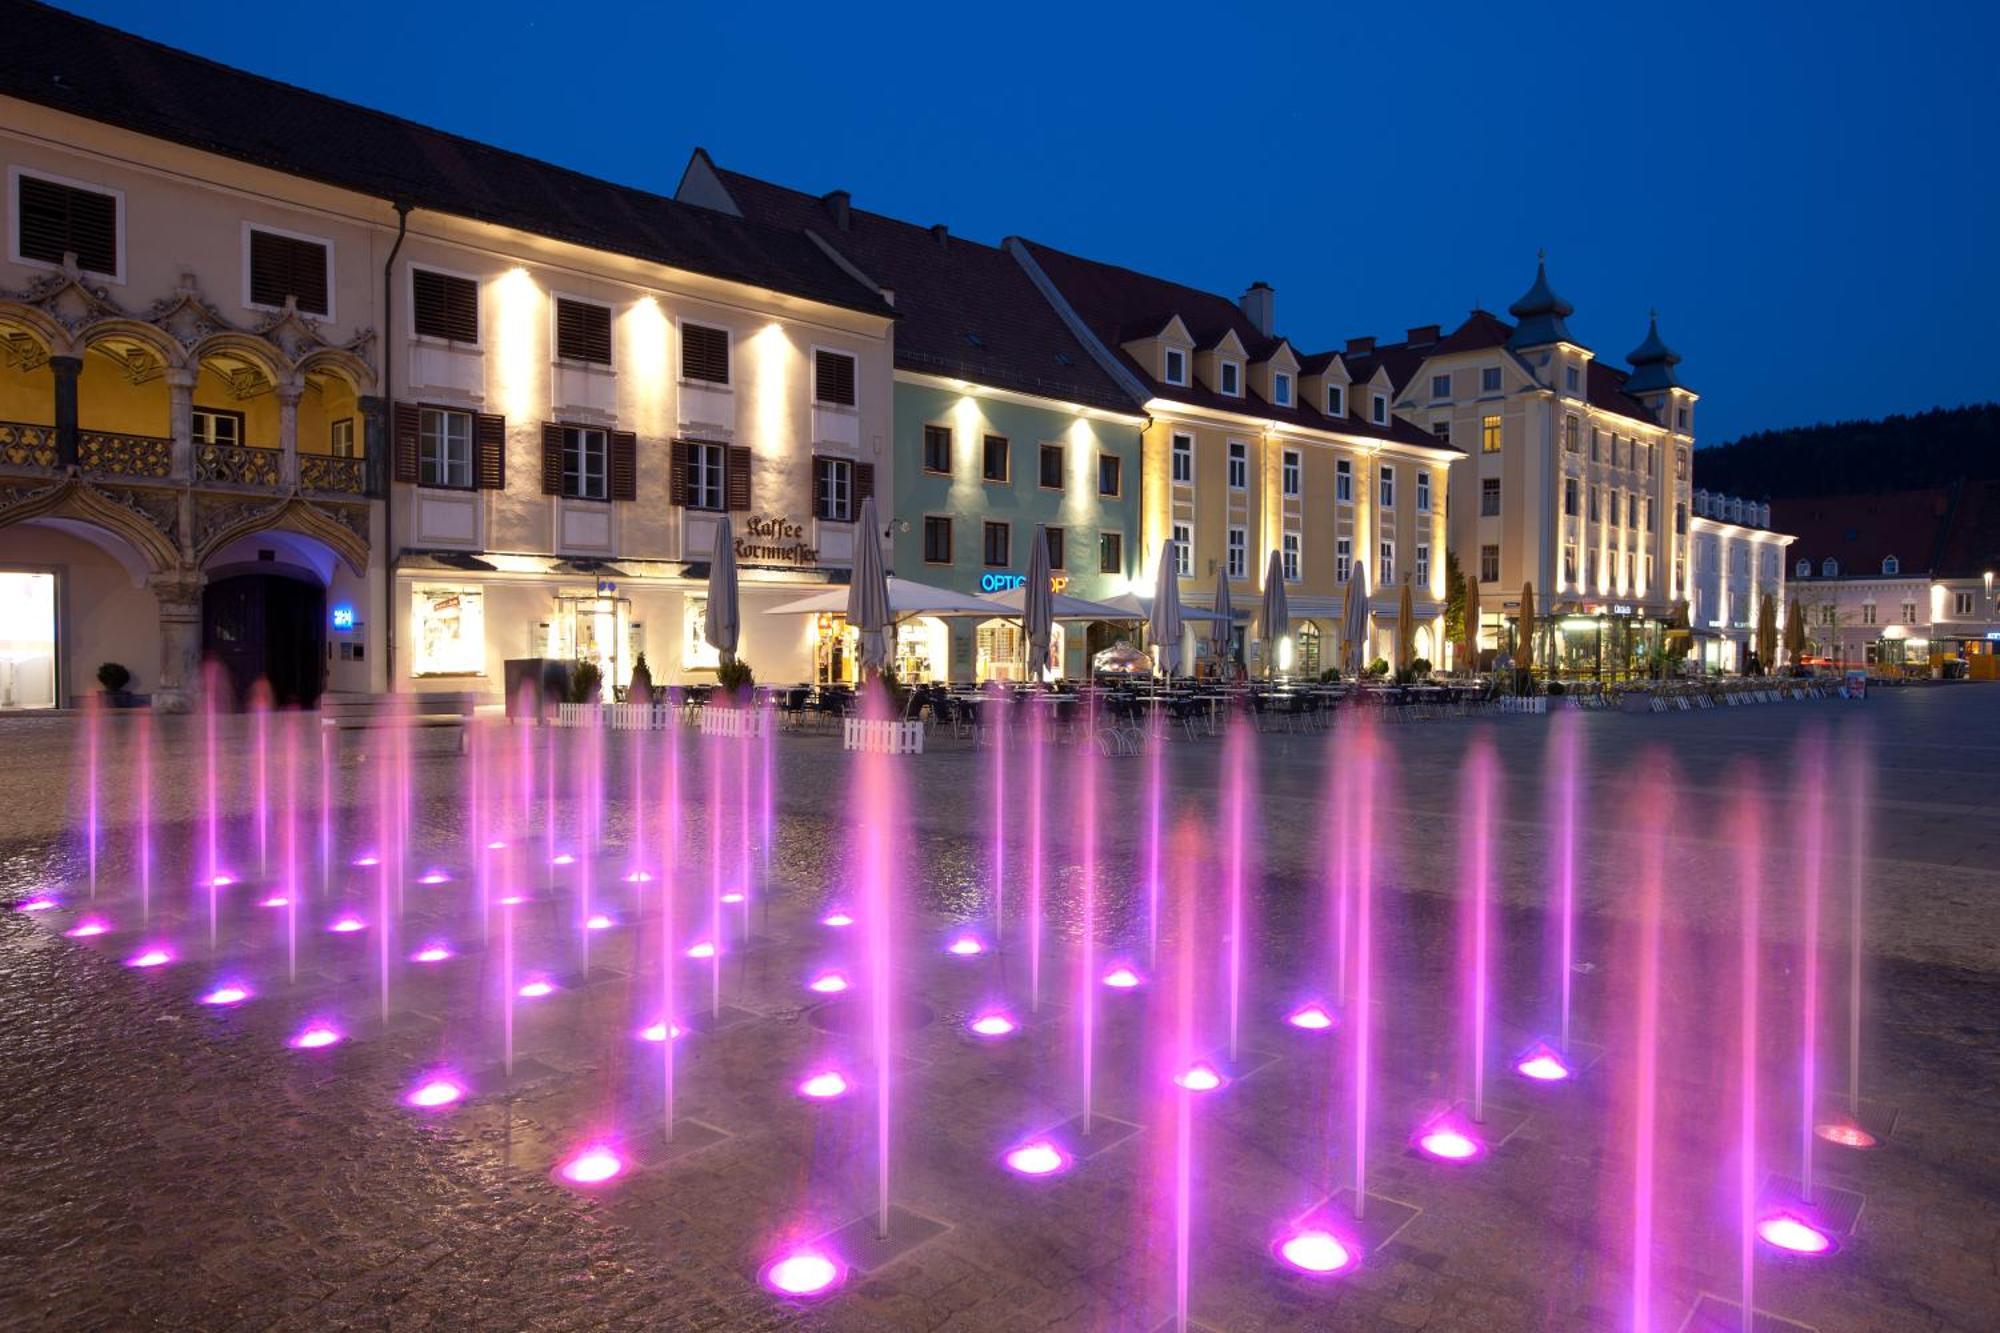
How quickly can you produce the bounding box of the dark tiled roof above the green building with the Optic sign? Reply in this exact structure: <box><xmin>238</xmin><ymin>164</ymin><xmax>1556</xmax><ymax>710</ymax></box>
<box><xmin>696</xmin><ymin>166</ymin><xmax>1138</xmax><ymax>414</ymax></box>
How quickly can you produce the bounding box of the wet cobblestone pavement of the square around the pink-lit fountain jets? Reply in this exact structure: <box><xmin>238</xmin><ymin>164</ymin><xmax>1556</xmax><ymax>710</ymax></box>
<box><xmin>0</xmin><ymin>687</ymin><xmax>2000</xmax><ymax>1333</ymax></box>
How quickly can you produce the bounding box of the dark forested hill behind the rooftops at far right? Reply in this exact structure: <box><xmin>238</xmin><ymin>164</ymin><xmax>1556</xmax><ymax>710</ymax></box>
<box><xmin>1694</xmin><ymin>402</ymin><xmax>2000</xmax><ymax>500</ymax></box>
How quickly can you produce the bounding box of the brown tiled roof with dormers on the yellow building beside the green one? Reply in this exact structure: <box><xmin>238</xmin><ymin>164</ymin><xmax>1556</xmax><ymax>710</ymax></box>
<box><xmin>1020</xmin><ymin>240</ymin><xmax>1452</xmax><ymax>448</ymax></box>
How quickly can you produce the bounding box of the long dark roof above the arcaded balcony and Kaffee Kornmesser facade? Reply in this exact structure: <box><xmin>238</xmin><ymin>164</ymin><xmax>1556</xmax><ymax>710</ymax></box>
<box><xmin>0</xmin><ymin>0</ymin><xmax>890</xmax><ymax>314</ymax></box>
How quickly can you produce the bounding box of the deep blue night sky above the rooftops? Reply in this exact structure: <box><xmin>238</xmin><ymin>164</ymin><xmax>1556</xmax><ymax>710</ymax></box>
<box><xmin>54</xmin><ymin>0</ymin><xmax>2000</xmax><ymax>442</ymax></box>
